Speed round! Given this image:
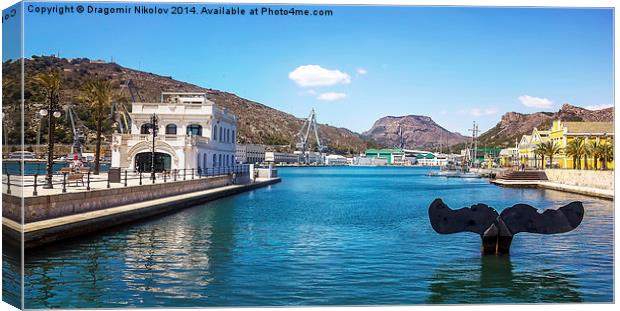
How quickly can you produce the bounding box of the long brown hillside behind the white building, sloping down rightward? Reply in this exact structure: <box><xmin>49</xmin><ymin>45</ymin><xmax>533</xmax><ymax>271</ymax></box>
<box><xmin>2</xmin><ymin>56</ymin><xmax>375</xmax><ymax>154</ymax></box>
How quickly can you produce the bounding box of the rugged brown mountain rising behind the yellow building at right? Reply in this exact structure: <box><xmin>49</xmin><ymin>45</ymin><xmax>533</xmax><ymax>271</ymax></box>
<box><xmin>478</xmin><ymin>104</ymin><xmax>614</xmax><ymax>147</ymax></box>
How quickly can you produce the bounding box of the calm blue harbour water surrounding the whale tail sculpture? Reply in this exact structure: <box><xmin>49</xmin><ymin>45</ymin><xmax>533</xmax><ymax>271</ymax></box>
<box><xmin>3</xmin><ymin>167</ymin><xmax>613</xmax><ymax>308</ymax></box>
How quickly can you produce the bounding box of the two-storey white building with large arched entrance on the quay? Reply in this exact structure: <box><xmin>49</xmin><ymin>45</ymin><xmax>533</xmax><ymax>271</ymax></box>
<box><xmin>111</xmin><ymin>92</ymin><xmax>237</xmax><ymax>171</ymax></box>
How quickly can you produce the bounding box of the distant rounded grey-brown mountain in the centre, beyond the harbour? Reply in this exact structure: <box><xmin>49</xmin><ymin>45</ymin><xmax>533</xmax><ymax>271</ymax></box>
<box><xmin>362</xmin><ymin>115</ymin><xmax>468</xmax><ymax>148</ymax></box>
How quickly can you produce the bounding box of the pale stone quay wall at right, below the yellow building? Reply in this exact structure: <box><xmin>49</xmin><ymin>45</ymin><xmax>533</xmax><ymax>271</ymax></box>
<box><xmin>545</xmin><ymin>169</ymin><xmax>614</xmax><ymax>190</ymax></box>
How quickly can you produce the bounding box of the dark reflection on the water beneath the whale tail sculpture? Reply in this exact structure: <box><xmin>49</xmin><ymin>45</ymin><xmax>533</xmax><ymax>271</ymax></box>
<box><xmin>427</xmin><ymin>256</ymin><xmax>583</xmax><ymax>304</ymax></box>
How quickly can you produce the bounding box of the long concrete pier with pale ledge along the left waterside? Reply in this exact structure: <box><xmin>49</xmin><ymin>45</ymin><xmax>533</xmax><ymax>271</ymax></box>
<box><xmin>2</xmin><ymin>177</ymin><xmax>281</xmax><ymax>248</ymax></box>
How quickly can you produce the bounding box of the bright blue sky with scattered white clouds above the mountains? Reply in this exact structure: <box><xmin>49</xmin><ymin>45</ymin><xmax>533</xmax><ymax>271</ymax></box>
<box><xmin>12</xmin><ymin>3</ymin><xmax>613</xmax><ymax>134</ymax></box>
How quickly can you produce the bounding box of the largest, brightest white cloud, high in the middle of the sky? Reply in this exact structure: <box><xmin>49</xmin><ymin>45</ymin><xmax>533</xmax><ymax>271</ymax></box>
<box><xmin>288</xmin><ymin>65</ymin><xmax>351</xmax><ymax>87</ymax></box>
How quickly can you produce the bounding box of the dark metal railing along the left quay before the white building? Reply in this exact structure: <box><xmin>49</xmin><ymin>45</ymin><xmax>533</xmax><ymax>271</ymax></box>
<box><xmin>2</xmin><ymin>165</ymin><xmax>250</xmax><ymax>196</ymax></box>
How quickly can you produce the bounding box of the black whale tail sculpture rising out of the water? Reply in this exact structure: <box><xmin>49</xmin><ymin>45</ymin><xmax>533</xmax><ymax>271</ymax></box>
<box><xmin>428</xmin><ymin>199</ymin><xmax>584</xmax><ymax>254</ymax></box>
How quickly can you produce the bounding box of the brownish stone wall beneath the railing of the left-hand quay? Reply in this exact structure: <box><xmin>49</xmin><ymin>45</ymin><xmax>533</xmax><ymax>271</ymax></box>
<box><xmin>2</xmin><ymin>176</ymin><xmax>231</xmax><ymax>223</ymax></box>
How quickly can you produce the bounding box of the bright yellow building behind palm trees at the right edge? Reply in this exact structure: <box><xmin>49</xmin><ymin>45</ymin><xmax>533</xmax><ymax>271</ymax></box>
<box><xmin>549</xmin><ymin>120</ymin><xmax>614</xmax><ymax>169</ymax></box>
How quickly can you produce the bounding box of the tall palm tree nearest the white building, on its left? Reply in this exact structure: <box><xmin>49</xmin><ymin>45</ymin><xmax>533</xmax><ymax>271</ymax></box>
<box><xmin>80</xmin><ymin>80</ymin><xmax>116</xmax><ymax>175</ymax></box>
